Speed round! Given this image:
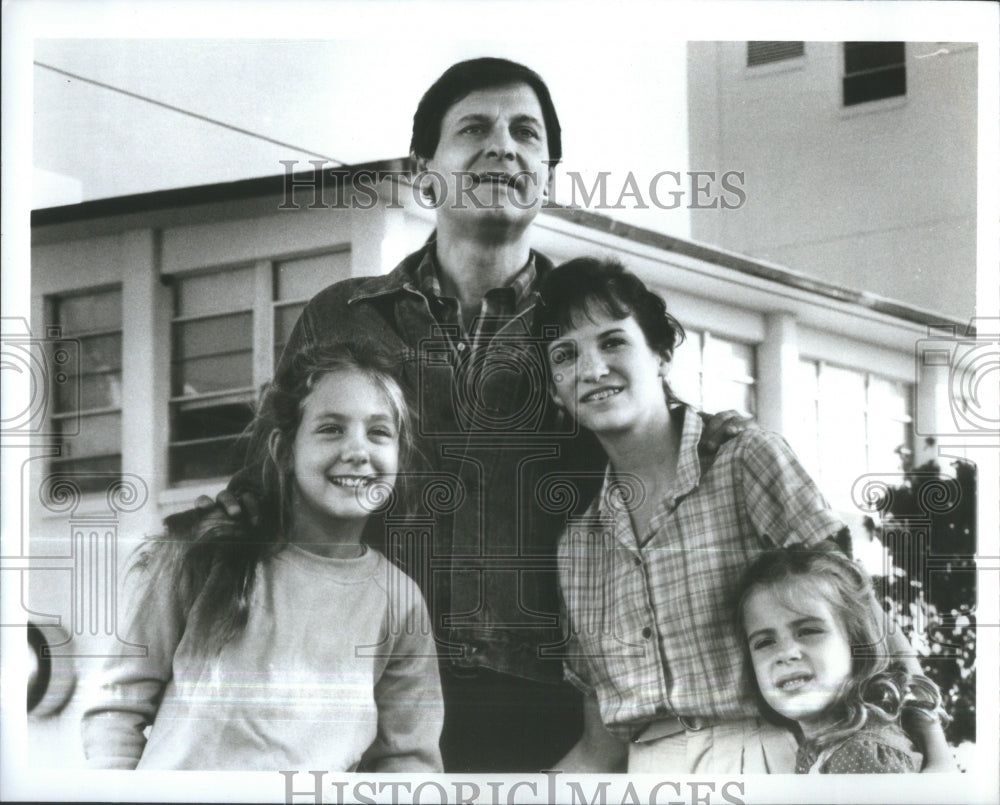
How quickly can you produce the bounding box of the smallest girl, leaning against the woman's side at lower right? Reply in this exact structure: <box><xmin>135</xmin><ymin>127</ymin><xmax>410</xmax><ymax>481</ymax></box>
<box><xmin>738</xmin><ymin>547</ymin><xmax>947</xmax><ymax>774</ymax></box>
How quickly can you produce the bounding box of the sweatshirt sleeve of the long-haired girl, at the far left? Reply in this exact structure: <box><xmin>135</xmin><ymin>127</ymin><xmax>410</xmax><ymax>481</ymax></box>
<box><xmin>82</xmin><ymin>552</ymin><xmax>183</xmax><ymax>769</ymax></box>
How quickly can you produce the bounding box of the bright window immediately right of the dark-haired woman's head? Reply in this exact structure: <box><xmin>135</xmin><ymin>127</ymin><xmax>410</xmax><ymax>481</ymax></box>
<box><xmin>669</xmin><ymin>330</ymin><xmax>757</xmax><ymax>416</ymax></box>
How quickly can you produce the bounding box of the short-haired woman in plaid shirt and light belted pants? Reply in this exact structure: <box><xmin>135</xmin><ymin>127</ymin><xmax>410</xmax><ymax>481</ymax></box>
<box><xmin>540</xmin><ymin>258</ymin><xmax>947</xmax><ymax>774</ymax></box>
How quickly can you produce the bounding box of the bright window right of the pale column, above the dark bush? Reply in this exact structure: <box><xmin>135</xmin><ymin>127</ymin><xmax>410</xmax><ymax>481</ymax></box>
<box><xmin>789</xmin><ymin>360</ymin><xmax>913</xmax><ymax>508</ymax></box>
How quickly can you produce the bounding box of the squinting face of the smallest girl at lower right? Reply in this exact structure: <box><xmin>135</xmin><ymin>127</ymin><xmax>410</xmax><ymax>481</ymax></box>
<box><xmin>743</xmin><ymin>585</ymin><xmax>851</xmax><ymax>738</ymax></box>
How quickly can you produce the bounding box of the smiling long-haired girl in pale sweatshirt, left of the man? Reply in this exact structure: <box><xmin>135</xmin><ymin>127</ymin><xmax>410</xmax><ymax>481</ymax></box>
<box><xmin>83</xmin><ymin>344</ymin><xmax>443</xmax><ymax>772</ymax></box>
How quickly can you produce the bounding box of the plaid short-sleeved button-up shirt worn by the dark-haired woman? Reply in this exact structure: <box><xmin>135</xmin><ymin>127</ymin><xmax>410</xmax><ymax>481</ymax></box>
<box><xmin>559</xmin><ymin>407</ymin><xmax>843</xmax><ymax>739</ymax></box>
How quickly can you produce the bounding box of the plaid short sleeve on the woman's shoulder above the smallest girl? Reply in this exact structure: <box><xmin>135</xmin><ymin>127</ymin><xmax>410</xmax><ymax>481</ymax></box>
<box><xmin>737</xmin><ymin>428</ymin><xmax>845</xmax><ymax>547</ymax></box>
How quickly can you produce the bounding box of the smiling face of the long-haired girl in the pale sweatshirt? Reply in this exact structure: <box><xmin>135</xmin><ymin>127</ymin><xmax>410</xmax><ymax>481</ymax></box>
<box><xmin>293</xmin><ymin>371</ymin><xmax>399</xmax><ymax>527</ymax></box>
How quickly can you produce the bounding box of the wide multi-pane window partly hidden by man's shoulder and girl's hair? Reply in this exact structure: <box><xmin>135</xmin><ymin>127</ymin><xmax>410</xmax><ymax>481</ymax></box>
<box><xmin>169</xmin><ymin>250</ymin><xmax>350</xmax><ymax>483</ymax></box>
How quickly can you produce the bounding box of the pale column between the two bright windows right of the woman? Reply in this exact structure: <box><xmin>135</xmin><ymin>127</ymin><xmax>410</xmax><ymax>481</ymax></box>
<box><xmin>757</xmin><ymin>313</ymin><xmax>799</xmax><ymax>437</ymax></box>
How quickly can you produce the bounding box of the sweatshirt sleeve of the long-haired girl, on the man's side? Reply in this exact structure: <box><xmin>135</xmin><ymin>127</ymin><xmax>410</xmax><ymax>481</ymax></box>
<box><xmin>361</xmin><ymin>571</ymin><xmax>444</xmax><ymax>773</ymax></box>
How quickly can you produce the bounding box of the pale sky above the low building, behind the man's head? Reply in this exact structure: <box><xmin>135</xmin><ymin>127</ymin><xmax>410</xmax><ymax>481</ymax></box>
<box><xmin>32</xmin><ymin>38</ymin><xmax>688</xmax><ymax>235</ymax></box>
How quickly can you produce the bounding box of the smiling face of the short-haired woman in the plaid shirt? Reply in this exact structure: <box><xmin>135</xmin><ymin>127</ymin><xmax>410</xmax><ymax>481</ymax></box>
<box><xmin>548</xmin><ymin>306</ymin><xmax>669</xmax><ymax>436</ymax></box>
